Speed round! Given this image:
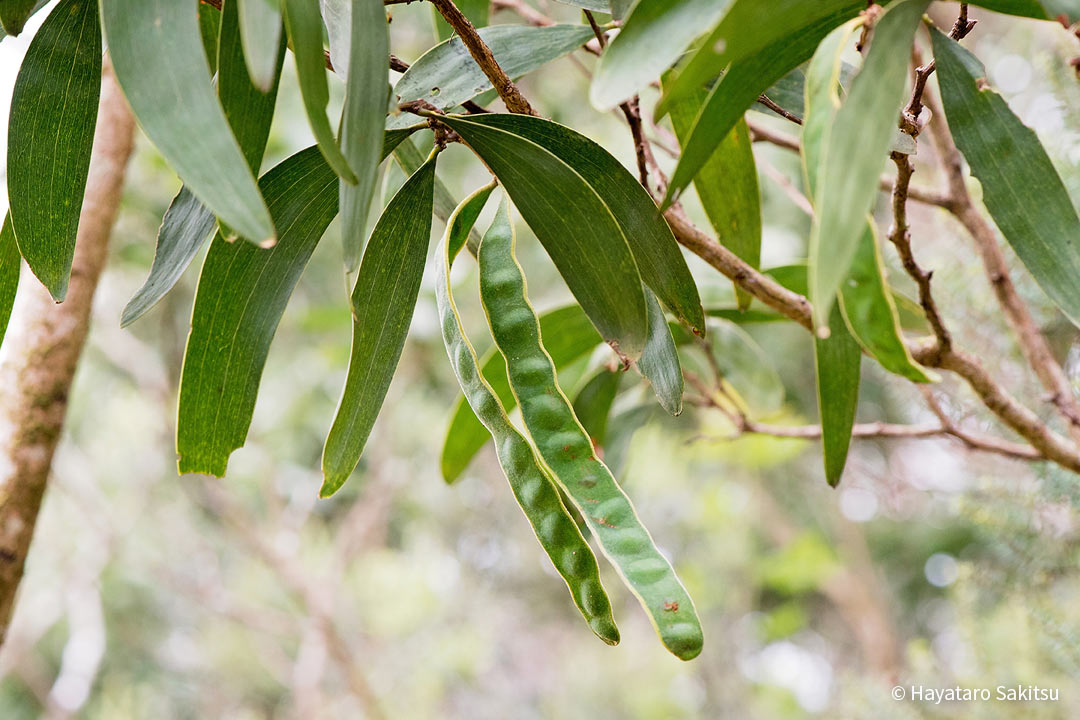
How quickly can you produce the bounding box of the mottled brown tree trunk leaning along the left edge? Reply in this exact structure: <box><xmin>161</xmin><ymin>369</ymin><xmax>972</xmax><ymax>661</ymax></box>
<box><xmin>0</xmin><ymin>68</ymin><xmax>135</xmax><ymax>646</ymax></box>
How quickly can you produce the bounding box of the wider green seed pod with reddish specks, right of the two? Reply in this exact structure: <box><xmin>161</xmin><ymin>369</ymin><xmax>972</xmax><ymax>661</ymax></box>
<box><xmin>478</xmin><ymin>201</ymin><xmax>702</xmax><ymax>660</ymax></box>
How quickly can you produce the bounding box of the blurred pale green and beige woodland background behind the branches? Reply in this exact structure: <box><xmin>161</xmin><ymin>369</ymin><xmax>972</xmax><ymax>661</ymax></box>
<box><xmin>0</xmin><ymin>0</ymin><xmax>1080</xmax><ymax>720</ymax></box>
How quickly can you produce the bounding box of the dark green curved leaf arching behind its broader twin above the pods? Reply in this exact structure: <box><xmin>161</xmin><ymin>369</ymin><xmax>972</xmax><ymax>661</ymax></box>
<box><xmin>460</xmin><ymin>112</ymin><xmax>704</xmax><ymax>331</ymax></box>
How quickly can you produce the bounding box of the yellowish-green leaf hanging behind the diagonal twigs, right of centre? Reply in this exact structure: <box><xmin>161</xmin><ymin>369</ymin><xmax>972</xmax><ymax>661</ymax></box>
<box><xmin>671</xmin><ymin>77</ymin><xmax>761</xmax><ymax>309</ymax></box>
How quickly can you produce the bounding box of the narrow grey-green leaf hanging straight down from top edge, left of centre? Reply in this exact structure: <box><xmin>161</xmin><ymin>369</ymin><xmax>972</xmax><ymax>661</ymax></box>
<box><xmin>339</xmin><ymin>0</ymin><xmax>390</xmax><ymax>272</ymax></box>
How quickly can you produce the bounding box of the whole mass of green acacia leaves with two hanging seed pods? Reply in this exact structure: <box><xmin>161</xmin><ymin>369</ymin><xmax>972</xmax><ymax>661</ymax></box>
<box><xmin>6</xmin><ymin>0</ymin><xmax>1080</xmax><ymax>658</ymax></box>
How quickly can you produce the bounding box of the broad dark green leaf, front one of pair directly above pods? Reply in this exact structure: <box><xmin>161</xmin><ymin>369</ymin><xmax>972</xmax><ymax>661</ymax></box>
<box><xmin>442</xmin><ymin>116</ymin><xmax>651</xmax><ymax>359</ymax></box>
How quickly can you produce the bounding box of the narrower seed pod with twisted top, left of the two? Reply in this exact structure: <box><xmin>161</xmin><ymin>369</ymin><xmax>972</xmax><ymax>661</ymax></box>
<box><xmin>435</xmin><ymin>185</ymin><xmax>619</xmax><ymax>644</ymax></box>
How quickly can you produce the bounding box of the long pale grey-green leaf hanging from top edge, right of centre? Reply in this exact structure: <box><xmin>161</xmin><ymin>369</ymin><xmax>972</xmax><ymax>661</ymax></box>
<box><xmin>808</xmin><ymin>0</ymin><xmax>930</xmax><ymax>326</ymax></box>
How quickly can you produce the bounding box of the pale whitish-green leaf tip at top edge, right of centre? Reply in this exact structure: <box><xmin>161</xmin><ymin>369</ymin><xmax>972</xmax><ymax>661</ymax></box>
<box><xmin>589</xmin><ymin>0</ymin><xmax>731</xmax><ymax>110</ymax></box>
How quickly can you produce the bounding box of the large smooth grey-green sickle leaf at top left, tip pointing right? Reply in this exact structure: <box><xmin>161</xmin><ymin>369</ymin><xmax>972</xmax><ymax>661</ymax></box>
<box><xmin>102</xmin><ymin>0</ymin><xmax>274</xmax><ymax>245</ymax></box>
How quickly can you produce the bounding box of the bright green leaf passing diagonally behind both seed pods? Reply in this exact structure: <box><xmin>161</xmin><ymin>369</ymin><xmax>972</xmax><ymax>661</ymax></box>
<box><xmin>440</xmin><ymin>305</ymin><xmax>603</xmax><ymax>484</ymax></box>
